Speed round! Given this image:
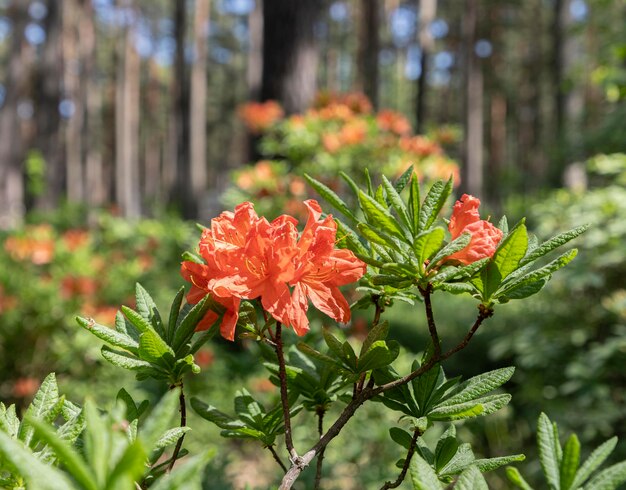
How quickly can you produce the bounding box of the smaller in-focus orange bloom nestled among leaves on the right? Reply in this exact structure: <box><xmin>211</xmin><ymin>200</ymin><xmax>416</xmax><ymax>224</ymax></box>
<box><xmin>445</xmin><ymin>194</ymin><xmax>502</xmax><ymax>265</ymax></box>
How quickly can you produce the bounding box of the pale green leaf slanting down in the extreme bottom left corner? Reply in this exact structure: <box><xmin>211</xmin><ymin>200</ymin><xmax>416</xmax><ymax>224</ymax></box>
<box><xmin>0</xmin><ymin>432</ymin><xmax>77</xmax><ymax>490</ymax></box>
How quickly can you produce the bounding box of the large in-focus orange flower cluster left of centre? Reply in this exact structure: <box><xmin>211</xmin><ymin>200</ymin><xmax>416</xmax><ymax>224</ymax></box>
<box><xmin>181</xmin><ymin>200</ymin><xmax>366</xmax><ymax>340</ymax></box>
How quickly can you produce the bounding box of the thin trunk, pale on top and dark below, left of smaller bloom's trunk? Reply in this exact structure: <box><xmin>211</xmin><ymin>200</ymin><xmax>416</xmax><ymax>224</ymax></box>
<box><xmin>415</xmin><ymin>0</ymin><xmax>437</xmax><ymax>134</ymax></box>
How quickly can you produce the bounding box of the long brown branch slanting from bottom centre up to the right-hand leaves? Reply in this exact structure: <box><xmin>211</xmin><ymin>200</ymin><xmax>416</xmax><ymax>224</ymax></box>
<box><xmin>279</xmin><ymin>305</ymin><xmax>493</xmax><ymax>490</ymax></box>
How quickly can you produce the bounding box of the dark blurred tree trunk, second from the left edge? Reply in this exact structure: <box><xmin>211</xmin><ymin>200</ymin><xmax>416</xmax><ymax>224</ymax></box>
<box><xmin>34</xmin><ymin>0</ymin><xmax>65</xmax><ymax>210</ymax></box>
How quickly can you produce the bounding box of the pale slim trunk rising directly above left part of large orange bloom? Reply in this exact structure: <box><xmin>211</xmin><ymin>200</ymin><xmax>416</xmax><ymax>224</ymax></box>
<box><xmin>189</xmin><ymin>0</ymin><xmax>210</xmax><ymax>218</ymax></box>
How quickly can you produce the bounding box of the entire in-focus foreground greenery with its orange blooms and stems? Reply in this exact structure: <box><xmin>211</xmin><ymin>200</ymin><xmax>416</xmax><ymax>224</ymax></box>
<box><xmin>0</xmin><ymin>170</ymin><xmax>626</xmax><ymax>490</ymax></box>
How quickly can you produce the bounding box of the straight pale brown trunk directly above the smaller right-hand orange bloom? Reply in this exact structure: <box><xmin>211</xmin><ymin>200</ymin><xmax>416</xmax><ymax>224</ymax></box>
<box><xmin>461</xmin><ymin>0</ymin><xmax>483</xmax><ymax>197</ymax></box>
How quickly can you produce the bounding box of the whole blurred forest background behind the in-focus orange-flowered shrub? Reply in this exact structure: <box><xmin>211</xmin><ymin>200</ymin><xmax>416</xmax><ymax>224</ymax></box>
<box><xmin>0</xmin><ymin>0</ymin><xmax>626</xmax><ymax>489</ymax></box>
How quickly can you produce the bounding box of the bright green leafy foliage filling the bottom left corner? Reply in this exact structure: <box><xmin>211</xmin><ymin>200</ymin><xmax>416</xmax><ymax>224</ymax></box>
<box><xmin>0</xmin><ymin>374</ymin><xmax>208</xmax><ymax>490</ymax></box>
